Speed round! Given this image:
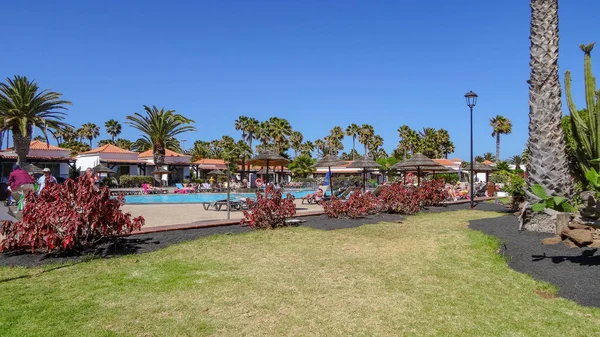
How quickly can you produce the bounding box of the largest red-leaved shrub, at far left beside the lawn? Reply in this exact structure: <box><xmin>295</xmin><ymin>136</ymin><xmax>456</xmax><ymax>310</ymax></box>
<box><xmin>0</xmin><ymin>178</ymin><xmax>144</xmax><ymax>252</ymax></box>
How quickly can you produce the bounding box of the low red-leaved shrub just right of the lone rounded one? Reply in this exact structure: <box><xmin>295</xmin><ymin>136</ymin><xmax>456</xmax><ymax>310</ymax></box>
<box><xmin>321</xmin><ymin>192</ymin><xmax>379</xmax><ymax>219</ymax></box>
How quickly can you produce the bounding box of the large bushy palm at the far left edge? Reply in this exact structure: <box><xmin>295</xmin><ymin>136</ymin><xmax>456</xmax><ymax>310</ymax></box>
<box><xmin>0</xmin><ymin>76</ymin><xmax>71</xmax><ymax>164</ymax></box>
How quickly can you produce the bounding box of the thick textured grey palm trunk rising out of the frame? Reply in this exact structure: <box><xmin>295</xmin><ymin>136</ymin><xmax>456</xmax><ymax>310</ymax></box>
<box><xmin>527</xmin><ymin>0</ymin><xmax>573</xmax><ymax>197</ymax></box>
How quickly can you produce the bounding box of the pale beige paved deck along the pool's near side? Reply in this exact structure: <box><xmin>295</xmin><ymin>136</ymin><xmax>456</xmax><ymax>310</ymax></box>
<box><xmin>122</xmin><ymin>199</ymin><xmax>323</xmax><ymax>233</ymax></box>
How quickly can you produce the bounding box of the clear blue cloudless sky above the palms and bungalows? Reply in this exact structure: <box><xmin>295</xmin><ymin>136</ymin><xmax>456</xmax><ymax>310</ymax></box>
<box><xmin>0</xmin><ymin>0</ymin><xmax>600</xmax><ymax>160</ymax></box>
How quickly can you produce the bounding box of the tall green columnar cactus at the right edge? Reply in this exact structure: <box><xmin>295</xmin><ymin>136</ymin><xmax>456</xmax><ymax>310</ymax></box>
<box><xmin>565</xmin><ymin>43</ymin><xmax>600</xmax><ymax>176</ymax></box>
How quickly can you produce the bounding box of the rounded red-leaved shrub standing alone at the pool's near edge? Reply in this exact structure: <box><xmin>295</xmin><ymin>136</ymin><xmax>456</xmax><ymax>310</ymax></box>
<box><xmin>241</xmin><ymin>185</ymin><xmax>296</xmax><ymax>229</ymax></box>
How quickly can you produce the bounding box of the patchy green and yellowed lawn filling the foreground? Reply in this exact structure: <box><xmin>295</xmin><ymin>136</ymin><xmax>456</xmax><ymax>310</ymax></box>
<box><xmin>0</xmin><ymin>211</ymin><xmax>600</xmax><ymax>336</ymax></box>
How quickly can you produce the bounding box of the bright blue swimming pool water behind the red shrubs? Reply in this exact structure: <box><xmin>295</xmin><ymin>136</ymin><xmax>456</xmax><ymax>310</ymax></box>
<box><xmin>125</xmin><ymin>191</ymin><xmax>313</xmax><ymax>204</ymax></box>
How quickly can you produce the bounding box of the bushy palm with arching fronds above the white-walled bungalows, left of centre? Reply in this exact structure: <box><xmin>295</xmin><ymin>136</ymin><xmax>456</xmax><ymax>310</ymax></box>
<box><xmin>126</xmin><ymin>105</ymin><xmax>196</xmax><ymax>170</ymax></box>
